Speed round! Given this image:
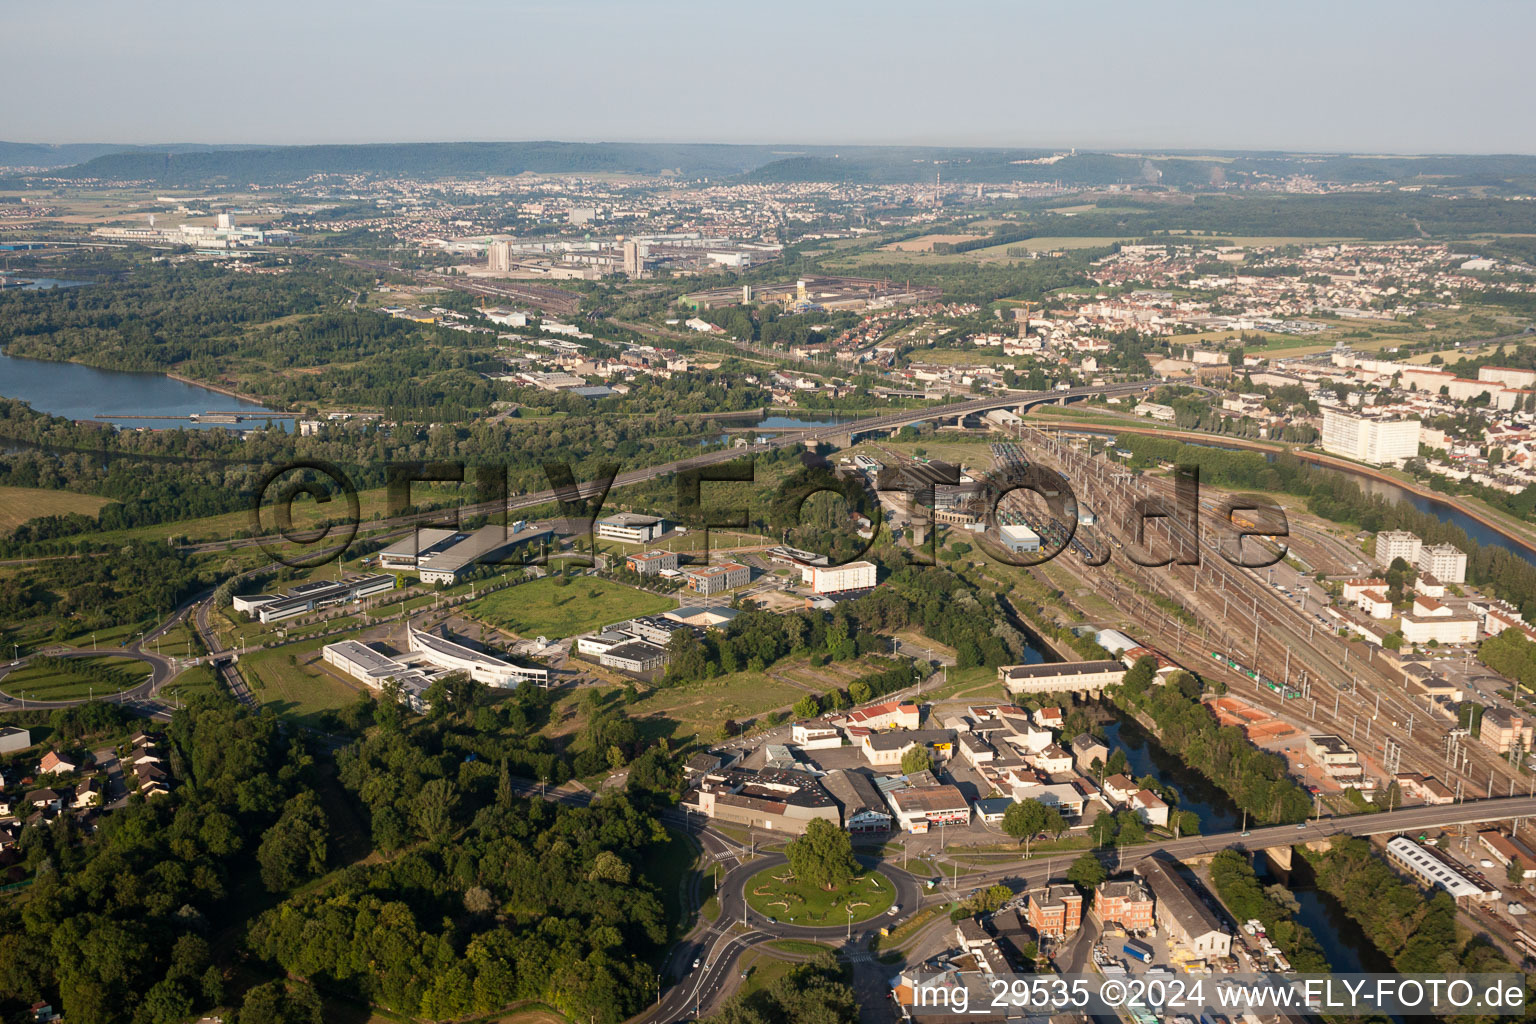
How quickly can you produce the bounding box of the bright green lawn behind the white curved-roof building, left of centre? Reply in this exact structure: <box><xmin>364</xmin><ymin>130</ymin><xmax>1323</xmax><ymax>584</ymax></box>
<box><xmin>464</xmin><ymin>576</ymin><xmax>677</xmax><ymax>640</ymax></box>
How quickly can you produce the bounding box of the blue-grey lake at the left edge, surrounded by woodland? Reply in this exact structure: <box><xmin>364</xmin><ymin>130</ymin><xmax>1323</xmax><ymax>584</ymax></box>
<box><xmin>0</xmin><ymin>352</ymin><xmax>292</xmax><ymax>430</ymax></box>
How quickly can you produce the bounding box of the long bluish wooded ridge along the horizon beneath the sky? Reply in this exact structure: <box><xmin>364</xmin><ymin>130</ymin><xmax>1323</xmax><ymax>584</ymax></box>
<box><xmin>18</xmin><ymin>141</ymin><xmax>1536</xmax><ymax>189</ymax></box>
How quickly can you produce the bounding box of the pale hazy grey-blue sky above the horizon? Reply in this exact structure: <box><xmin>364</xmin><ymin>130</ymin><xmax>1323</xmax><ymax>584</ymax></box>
<box><xmin>0</xmin><ymin>0</ymin><xmax>1536</xmax><ymax>154</ymax></box>
